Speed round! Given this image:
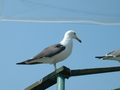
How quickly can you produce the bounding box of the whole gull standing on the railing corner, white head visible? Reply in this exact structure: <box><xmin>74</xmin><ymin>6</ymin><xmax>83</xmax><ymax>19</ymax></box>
<box><xmin>16</xmin><ymin>30</ymin><xmax>81</xmax><ymax>70</ymax></box>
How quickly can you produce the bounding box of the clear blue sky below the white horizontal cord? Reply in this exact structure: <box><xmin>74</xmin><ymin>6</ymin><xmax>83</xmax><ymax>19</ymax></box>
<box><xmin>0</xmin><ymin>0</ymin><xmax>120</xmax><ymax>90</ymax></box>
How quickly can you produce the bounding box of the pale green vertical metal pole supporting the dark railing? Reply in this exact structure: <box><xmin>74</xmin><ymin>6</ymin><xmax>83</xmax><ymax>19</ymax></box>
<box><xmin>57</xmin><ymin>74</ymin><xmax>65</xmax><ymax>90</ymax></box>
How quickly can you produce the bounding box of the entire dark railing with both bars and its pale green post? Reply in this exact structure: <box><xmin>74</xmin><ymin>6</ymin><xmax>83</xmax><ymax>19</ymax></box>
<box><xmin>24</xmin><ymin>66</ymin><xmax>120</xmax><ymax>90</ymax></box>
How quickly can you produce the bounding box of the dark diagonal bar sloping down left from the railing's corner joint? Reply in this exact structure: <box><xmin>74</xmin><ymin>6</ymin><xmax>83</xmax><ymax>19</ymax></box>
<box><xmin>24</xmin><ymin>66</ymin><xmax>70</xmax><ymax>90</ymax></box>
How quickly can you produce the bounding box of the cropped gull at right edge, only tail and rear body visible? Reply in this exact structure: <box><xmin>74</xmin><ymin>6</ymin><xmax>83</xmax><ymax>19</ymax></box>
<box><xmin>95</xmin><ymin>49</ymin><xmax>120</xmax><ymax>62</ymax></box>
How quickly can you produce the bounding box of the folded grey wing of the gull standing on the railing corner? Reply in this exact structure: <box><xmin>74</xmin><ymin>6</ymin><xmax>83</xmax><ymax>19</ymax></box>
<box><xmin>32</xmin><ymin>44</ymin><xmax>65</xmax><ymax>59</ymax></box>
